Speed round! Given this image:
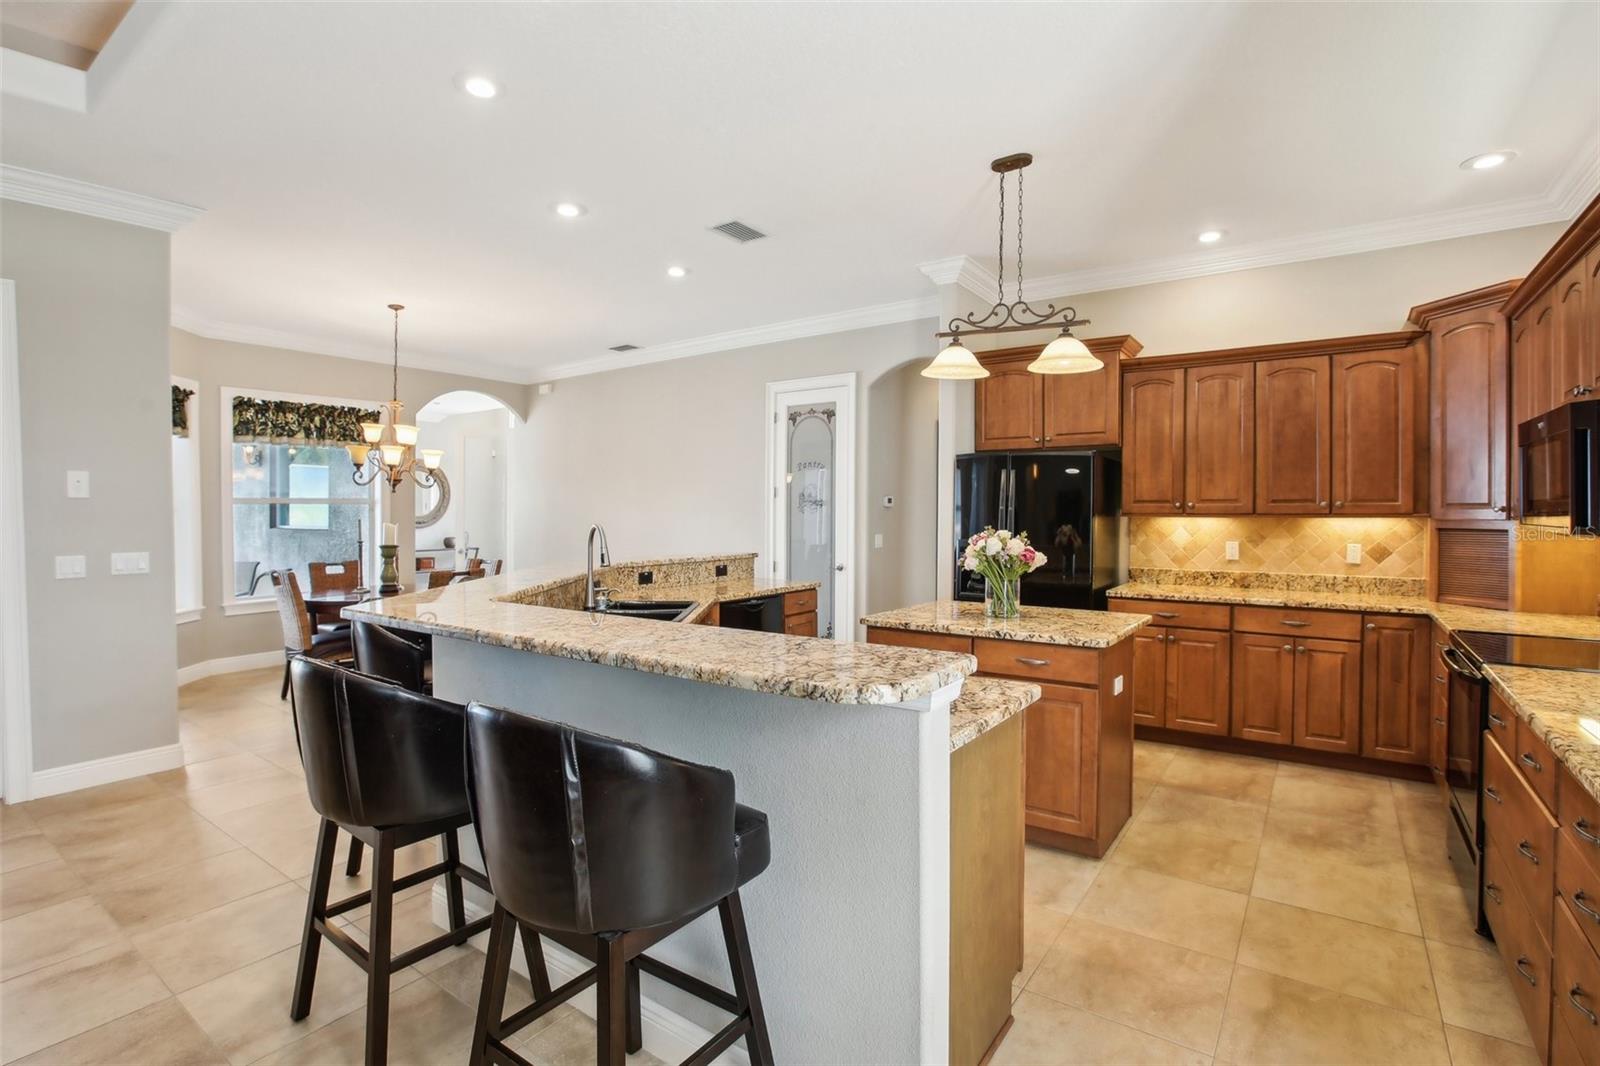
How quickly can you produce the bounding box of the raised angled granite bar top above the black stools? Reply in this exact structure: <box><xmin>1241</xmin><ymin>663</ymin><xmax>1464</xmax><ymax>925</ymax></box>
<box><xmin>344</xmin><ymin>567</ymin><xmax>978</xmax><ymax>704</ymax></box>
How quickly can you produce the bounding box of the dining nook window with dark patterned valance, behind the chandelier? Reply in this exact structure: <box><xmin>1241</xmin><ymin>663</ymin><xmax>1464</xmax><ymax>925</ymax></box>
<box><xmin>222</xmin><ymin>389</ymin><xmax>378</xmax><ymax>610</ymax></box>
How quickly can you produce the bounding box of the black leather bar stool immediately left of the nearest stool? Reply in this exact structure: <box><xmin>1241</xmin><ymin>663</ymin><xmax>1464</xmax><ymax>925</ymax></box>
<box><xmin>290</xmin><ymin>656</ymin><xmax>490</xmax><ymax>1066</ymax></box>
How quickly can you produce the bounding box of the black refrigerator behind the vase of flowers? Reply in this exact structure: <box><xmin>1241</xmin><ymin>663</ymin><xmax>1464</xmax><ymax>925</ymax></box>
<box><xmin>954</xmin><ymin>451</ymin><xmax>1122</xmax><ymax>610</ymax></box>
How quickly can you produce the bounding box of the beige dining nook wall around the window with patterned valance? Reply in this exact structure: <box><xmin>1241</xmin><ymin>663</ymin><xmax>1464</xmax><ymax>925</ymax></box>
<box><xmin>172</xmin><ymin>330</ymin><xmax>530</xmax><ymax>666</ymax></box>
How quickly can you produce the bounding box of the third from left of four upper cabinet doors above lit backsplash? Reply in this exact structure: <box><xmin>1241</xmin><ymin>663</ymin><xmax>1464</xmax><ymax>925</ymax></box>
<box><xmin>1256</xmin><ymin>355</ymin><xmax>1333</xmax><ymax>514</ymax></box>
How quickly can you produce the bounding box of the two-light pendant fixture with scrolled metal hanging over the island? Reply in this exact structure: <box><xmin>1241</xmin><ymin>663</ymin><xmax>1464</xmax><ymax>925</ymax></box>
<box><xmin>922</xmin><ymin>152</ymin><xmax>1104</xmax><ymax>381</ymax></box>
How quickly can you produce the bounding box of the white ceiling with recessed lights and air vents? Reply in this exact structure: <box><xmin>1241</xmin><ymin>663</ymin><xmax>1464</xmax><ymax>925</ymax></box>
<box><xmin>0</xmin><ymin>0</ymin><xmax>1600</xmax><ymax>381</ymax></box>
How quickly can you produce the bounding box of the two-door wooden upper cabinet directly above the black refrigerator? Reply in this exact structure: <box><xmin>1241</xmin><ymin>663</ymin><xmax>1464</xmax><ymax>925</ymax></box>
<box><xmin>974</xmin><ymin>336</ymin><xmax>1142</xmax><ymax>451</ymax></box>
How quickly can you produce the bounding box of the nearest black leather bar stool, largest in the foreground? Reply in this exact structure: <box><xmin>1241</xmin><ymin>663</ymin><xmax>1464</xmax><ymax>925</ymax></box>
<box><xmin>467</xmin><ymin>703</ymin><xmax>773</xmax><ymax>1066</ymax></box>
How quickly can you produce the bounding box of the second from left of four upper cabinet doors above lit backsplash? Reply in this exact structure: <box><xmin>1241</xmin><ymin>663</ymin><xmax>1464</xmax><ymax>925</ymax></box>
<box><xmin>1184</xmin><ymin>363</ymin><xmax>1256</xmax><ymax>514</ymax></box>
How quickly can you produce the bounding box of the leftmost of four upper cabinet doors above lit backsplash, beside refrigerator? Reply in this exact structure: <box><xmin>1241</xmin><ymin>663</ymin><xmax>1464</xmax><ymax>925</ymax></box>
<box><xmin>1122</xmin><ymin>370</ymin><xmax>1184</xmax><ymax>514</ymax></box>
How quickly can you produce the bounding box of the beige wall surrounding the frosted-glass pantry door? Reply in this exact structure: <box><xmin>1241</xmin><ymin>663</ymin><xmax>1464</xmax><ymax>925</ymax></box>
<box><xmin>510</xmin><ymin>320</ymin><xmax>938</xmax><ymax>627</ymax></box>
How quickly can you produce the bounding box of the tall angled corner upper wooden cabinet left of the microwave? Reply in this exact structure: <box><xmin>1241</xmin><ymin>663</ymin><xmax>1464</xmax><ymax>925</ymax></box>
<box><xmin>1410</xmin><ymin>282</ymin><xmax>1517</xmax><ymax>520</ymax></box>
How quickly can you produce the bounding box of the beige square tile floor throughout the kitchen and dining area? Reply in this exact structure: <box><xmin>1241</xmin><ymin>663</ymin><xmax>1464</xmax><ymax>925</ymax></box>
<box><xmin>0</xmin><ymin>671</ymin><xmax>1534</xmax><ymax>1066</ymax></box>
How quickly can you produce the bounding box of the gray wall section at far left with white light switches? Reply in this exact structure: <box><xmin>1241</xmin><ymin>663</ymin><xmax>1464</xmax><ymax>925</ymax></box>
<box><xmin>0</xmin><ymin>200</ymin><xmax>178</xmax><ymax>771</ymax></box>
